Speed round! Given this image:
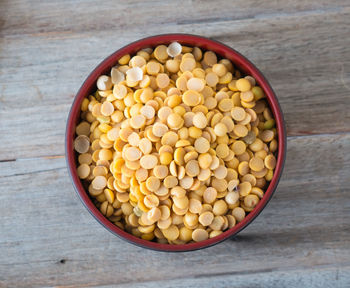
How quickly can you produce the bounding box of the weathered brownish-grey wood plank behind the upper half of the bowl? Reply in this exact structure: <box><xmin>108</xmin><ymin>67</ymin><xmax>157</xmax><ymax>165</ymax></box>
<box><xmin>0</xmin><ymin>7</ymin><xmax>350</xmax><ymax>160</ymax></box>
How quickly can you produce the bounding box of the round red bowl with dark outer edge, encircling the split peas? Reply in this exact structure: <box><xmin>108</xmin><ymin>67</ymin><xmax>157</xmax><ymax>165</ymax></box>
<box><xmin>66</xmin><ymin>34</ymin><xmax>286</xmax><ymax>252</ymax></box>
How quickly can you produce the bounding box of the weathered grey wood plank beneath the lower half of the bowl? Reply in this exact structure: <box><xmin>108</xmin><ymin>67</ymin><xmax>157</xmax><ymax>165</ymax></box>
<box><xmin>0</xmin><ymin>133</ymin><xmax>350</xmax><ymax>287</ymax></box>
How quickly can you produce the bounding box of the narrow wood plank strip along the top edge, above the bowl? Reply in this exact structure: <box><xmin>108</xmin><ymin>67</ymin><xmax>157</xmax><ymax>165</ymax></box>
<box><xmin>0</xmin><ymin>0</ymin><xmax>350</xmax><ymax>36</ymax></box>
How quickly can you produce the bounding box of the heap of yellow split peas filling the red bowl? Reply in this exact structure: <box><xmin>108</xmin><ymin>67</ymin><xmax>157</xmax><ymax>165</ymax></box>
<box><xmin>74</xmin><ymin>42</ymin><xmax>277</xmax><ymax>244</ymax></box>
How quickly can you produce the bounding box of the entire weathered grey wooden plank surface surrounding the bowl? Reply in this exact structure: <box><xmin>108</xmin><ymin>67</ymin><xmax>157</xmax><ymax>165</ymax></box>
<box><xmin>0</xmin><ymin>0</ymin><xmax>350</xmax><ymax>287</ymax></box>
